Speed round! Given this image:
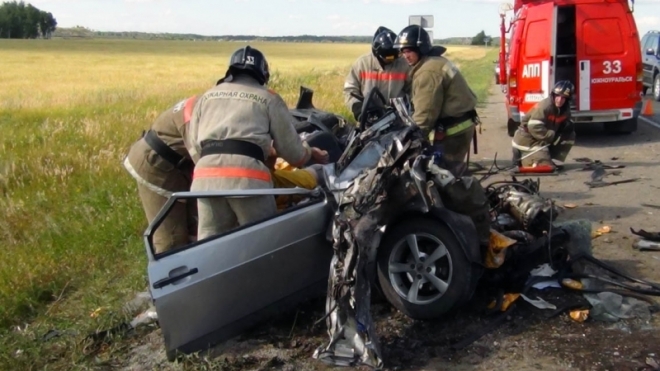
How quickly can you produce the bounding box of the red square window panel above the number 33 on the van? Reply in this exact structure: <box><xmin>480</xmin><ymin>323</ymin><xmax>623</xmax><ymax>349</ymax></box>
<box><xmin>582</xmin><ymin>18</ymin><xmax>626</xmax><ymax>55</ymax></box>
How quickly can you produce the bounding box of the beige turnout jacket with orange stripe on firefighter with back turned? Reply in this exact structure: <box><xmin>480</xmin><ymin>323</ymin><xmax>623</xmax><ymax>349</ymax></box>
<box><xmin>188</xmin><ymin>75</ymin><xmax>311</xmax><ymax>190</ymax></box>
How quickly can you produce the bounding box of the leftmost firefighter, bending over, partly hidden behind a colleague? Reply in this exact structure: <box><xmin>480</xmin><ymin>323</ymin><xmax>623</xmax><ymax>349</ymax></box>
<box><xmin>124</xmin><ymin>96</ymin><xmax>197</xmax><ymax>254</ymax></box>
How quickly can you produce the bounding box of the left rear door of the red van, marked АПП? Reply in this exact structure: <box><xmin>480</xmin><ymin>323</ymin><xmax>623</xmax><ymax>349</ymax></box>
<box><xmin>518</xmin><ymin>2</ymin><xmax>556</xmax><ymax>112</ymax></box>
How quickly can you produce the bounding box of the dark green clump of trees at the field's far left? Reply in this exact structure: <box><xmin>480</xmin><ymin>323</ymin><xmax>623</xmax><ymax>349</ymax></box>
<box><xmin>0</xmin><ymin>1</ymin><xmax>57</xmax><ymax>39</ymax></box>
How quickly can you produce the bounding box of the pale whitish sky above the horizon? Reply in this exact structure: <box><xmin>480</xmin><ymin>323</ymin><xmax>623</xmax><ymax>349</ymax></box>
<box><xmin>18</xmin><ymin>0</ymin><xmax>660</xmax><ymax>39</ymax></box>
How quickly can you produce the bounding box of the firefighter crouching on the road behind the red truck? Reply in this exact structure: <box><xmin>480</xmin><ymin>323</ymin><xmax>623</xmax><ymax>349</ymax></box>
<box><xmin>511</xmin><ymin>80</ymin><xmax>575</xmax><ymax>170</ymax></box>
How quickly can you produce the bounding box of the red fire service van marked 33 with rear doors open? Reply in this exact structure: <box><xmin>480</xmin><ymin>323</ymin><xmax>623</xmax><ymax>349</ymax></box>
<box><xmin>499</xmin><ymin>0</ymin><xmax>643</xmax><ymax>136</ymax></box>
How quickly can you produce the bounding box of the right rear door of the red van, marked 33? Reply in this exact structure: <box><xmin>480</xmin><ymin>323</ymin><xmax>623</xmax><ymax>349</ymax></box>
<box><xmin>575</xmin><ymin>3</ymin><xmax>639</xmax><ymax>111</ymax></box>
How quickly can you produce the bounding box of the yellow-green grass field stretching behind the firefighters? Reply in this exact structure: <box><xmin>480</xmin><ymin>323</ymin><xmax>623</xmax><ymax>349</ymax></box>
<box><xmin>0</xmin><ymin>40</ymin><xmax>497</xmax><ymax>370</ymax></box>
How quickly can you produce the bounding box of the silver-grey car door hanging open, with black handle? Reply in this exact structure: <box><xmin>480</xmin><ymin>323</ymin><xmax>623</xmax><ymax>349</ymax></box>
<box><xmin>145</xmin><ymin>189</ymin><xmax>333</xmax><ymax>352</ymax></box>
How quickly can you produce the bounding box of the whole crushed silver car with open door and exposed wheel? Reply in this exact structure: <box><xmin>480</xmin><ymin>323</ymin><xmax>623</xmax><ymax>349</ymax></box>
<box><xmin>144</xmin><ymin>89</ymin><xmax>660</xmax><ymax>369</ymax></box>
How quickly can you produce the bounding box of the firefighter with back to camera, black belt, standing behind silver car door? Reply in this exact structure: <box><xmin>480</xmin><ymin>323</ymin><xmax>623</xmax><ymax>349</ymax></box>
<box><xmin>188</xmin><ymin>46</ymin><xmax>328</xmax><ymax>239</ymax></box>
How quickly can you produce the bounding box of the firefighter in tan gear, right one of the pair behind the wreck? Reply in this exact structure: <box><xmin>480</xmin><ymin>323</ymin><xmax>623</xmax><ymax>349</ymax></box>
<box><xmin>394</xmin><ymin>25</ymin><xmax>479</xmax><ymax>176</ymax></box>
